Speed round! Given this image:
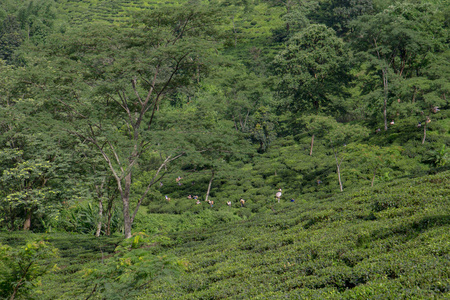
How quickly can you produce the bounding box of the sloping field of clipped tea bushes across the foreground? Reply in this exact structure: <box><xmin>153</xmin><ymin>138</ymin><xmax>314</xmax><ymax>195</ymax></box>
<box><xmin>1</xmin><ymin>171</ymin><xmax>450</xmax><ymax>299</ymax></box>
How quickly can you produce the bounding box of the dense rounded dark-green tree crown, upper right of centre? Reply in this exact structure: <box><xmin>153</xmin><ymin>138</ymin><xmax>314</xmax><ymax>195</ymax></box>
<box><xmin>274</xmin><ymin>24</ymin><xmax>348</xmax><ymax>112</ymax></box>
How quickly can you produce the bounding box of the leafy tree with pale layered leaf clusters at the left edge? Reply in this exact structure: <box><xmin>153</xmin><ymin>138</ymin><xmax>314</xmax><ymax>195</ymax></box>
<box><xmin>0</xmin><ymin>83</ymin><xmax>87</xmax><ymax>230</ymax></box>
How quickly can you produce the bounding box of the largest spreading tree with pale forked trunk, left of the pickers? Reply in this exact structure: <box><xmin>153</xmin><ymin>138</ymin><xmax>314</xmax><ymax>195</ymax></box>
<box><xmin>30</xmin><ymin>5</ymin><xmax>225</xmax><ymax>238</ymax></box>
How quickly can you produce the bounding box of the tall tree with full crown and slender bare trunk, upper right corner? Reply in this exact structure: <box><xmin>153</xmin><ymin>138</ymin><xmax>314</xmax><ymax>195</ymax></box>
<box><xmin>351</xmin><ymin>2</ymin><xmax>446</xmax><ymax>130</ymax></box>
